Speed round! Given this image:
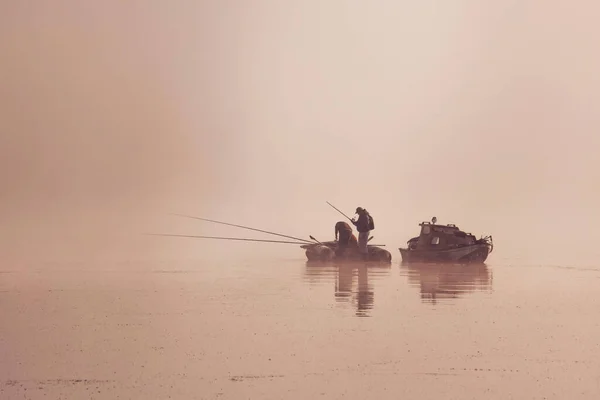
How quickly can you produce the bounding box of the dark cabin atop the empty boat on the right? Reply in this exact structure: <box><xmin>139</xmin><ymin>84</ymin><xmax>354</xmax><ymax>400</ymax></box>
<box><xmin>408</xmin><ymin>222</ymin><xmax>477</xmax><ymax>250</ymax></box>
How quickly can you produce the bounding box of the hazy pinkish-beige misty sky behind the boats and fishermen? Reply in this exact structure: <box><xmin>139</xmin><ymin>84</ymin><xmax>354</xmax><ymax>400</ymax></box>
<box><xmin>0</xmin><ymin>0</ymin><xmax>600</xmax><ymax>263</ymax></box>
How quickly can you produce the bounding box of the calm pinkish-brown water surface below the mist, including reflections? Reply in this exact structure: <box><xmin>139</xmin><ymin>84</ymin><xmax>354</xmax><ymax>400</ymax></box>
<box><xmin>0</xmin><ymin>254</ymin><xmax>600</xmax><ymax>400</ymax></box>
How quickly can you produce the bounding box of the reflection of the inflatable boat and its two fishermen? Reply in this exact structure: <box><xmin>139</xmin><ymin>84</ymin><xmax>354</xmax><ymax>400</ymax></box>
<box><xmin>306</xmin><ymin>262</ymin><xmax>391</xmax><ymax>317</ymax></box>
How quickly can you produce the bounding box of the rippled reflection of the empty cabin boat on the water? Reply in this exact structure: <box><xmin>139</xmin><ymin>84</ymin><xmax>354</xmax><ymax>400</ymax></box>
<box><xmin>400</xmin><ymin>264</ymin><xmax>493</xmax><ymax>304</ymax></box>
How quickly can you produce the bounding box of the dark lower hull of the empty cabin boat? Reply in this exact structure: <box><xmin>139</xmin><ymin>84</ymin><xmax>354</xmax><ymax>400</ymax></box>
<box><xmin>399</xmin><ymin>244</ymin><xmax>491</xmax><ymax>264</ymax></box>
